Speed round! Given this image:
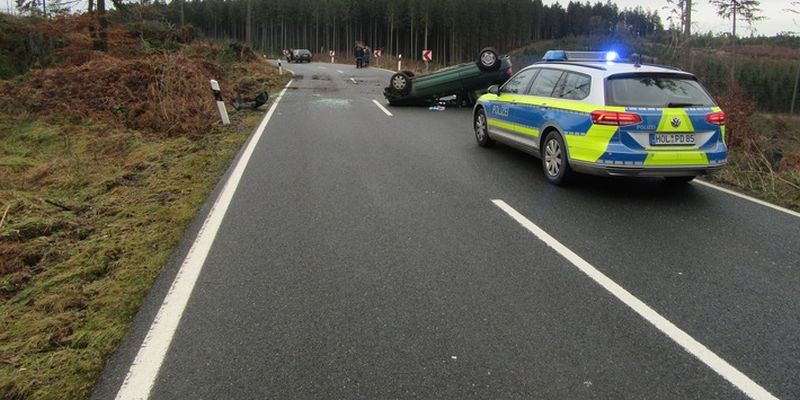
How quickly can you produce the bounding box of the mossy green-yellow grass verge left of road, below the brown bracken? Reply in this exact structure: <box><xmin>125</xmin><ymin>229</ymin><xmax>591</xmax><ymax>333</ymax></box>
<box><xmin>0</xmin><ymin>86</ymin><xmax>286</xmax><ymax>399</ymax></box>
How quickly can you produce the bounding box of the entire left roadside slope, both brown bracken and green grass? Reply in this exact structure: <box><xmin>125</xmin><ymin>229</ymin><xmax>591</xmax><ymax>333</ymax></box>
<box><xmin>0</xmin><ymin>18</ymin><xmax>288</xmax><ymax>399</ymax></box>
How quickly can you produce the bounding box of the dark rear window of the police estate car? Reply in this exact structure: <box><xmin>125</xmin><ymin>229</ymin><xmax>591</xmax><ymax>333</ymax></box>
<box><xmin>606</xmin><ymin>74</ymin><xmax>714</xmax><ymax>108</ymax></box>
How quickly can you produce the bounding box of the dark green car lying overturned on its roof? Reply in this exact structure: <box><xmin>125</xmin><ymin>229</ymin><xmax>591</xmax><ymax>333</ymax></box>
<box><xmin>383</xmin><ymin>47</ymin><xmax>513</xmax><ymax>105</ymax></box>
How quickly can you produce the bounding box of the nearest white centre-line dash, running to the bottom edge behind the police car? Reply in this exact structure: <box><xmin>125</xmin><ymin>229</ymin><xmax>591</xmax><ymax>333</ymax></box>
<box><xmin>492</xmin><ymin>200</ymin><xmax>777</xmax><ymax>400</ymax></box>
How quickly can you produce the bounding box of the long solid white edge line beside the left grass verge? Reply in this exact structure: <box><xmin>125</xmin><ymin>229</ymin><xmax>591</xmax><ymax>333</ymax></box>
<box><xmin>116</xmin><ymin>81</ymin><xmax>292</xmax><ymax>400</ymax></box>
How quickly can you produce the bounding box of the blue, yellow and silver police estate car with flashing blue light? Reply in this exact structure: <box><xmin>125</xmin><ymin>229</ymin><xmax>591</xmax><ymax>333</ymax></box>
<box><xmin>473</xmin><ymin>50</ymin><xmax>728</xmax><ymax>184</ymax></box>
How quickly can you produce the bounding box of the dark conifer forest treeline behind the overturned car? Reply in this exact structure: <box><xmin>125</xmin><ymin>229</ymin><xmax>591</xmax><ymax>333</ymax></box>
<box><xmin>175</xmin><ymin>0</ymin><xmax>663</xmax><ymax>64</ymax></box>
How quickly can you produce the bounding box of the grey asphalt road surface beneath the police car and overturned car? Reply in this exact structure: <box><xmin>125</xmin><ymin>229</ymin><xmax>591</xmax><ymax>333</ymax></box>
<box><xmin>94</xmin><ymin>63</ymin><xmax>800</xmax><ymax>399</ymax></box>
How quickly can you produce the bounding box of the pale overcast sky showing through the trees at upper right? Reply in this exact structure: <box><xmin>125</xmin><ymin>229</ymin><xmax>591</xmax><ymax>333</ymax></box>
<box><xmin>543</xmin><ymin>0</ymin><xmax>800</xmax><ymax>36</ymax></box>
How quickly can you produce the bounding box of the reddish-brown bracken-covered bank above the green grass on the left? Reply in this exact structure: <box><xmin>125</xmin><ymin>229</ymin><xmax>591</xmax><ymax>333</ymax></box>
<box><xmin>0</xmin><ymin>17</ymin><xmax>278</xmax><ymax>136</ymax></box>
